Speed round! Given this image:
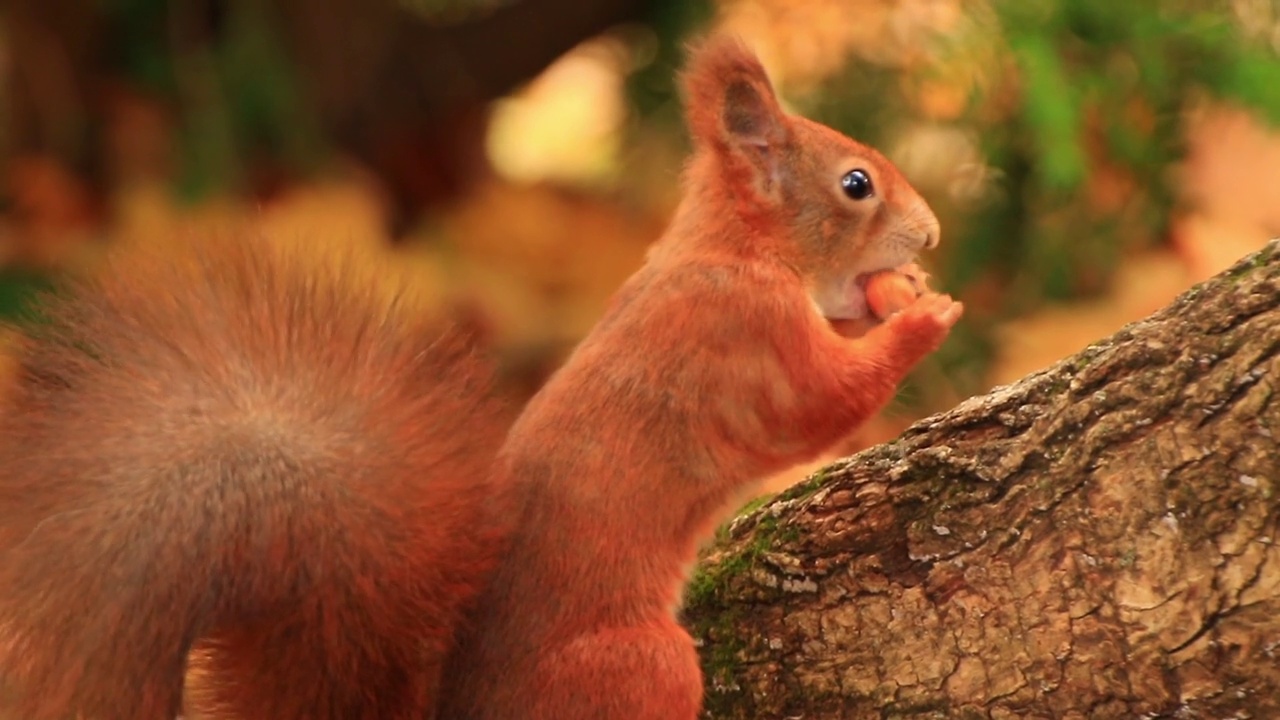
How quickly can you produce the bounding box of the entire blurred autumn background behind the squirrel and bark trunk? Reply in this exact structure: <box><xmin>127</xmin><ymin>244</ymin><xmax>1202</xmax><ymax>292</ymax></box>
<box><xmin>0</xmin><ymin>0</ymin><xmax>1280</xmax><ymax>487</ymax></box>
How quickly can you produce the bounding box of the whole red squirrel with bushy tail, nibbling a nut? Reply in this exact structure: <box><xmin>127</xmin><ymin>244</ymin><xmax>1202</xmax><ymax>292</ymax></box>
<box><xmin>0</xmin><ymin>38</ymin><xmax>961</xmax><ymax>720</ymax></box>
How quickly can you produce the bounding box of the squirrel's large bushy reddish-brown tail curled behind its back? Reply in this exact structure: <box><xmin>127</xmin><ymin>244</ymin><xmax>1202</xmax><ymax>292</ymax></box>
<box><xmin>0</xmin><ymin>238</ymin><xmax>509</xmax><ymax>720</ymax></box>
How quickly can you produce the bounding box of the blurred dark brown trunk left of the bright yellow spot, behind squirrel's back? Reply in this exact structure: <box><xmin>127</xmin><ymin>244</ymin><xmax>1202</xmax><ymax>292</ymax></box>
<box><xmin>274</xmin><ymin>0</ymin><xmax>652</xmax><ymax>224</ymax></box>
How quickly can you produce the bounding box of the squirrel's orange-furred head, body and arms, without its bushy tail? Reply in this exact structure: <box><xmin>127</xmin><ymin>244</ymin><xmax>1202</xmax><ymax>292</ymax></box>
<box><xmin>442</xmin><ymin>38</ymin><xmax>961</xmax><ymax>720</ymax></box>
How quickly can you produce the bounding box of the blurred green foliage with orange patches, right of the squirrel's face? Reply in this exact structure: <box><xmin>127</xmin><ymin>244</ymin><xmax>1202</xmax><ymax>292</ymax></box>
<box><xmin>815</xmin><ymin>0</ymin><xmax>1280</xmax><ymax>313</ymax></box>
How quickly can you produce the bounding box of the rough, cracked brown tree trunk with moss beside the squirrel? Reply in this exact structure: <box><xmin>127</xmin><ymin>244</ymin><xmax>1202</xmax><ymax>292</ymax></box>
<box><xmin>686</xmin><ymin>241</ymin><xmax>1280</xmax><ymax>720</ymax></box>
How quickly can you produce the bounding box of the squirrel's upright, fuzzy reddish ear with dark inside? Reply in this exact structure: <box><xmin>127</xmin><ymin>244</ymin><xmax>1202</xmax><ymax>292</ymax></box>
<box><xmin>681</xmin><ymin>36</ymin><xmax>786</xmax><ymax>149</ymax></box>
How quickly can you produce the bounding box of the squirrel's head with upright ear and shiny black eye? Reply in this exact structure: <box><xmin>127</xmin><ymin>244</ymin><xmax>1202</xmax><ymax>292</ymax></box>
<box><xmin>682</xmin><ymin>37</ymin><xmax>940</xmax><ymax>319</ymax></box>
